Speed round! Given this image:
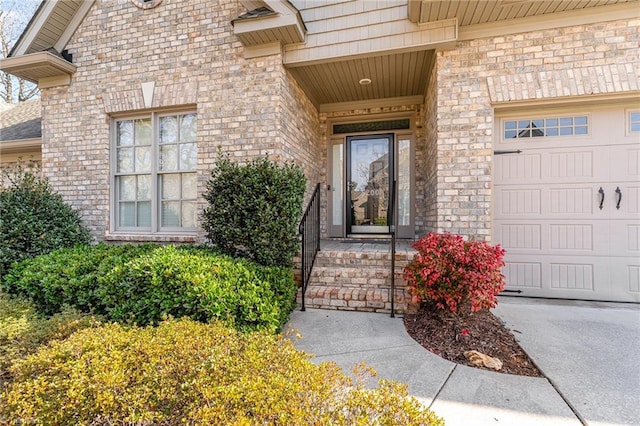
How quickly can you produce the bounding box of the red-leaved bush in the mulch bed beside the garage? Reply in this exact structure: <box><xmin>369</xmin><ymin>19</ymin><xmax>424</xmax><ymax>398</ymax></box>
<box><xmin>404</xmin><ymin>233</ymin><xmax>505</xmax><ymax>314</ymax></box>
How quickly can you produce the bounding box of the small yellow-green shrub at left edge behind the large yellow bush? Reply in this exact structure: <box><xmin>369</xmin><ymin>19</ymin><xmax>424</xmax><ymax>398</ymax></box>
<box><xmin>0</xmin><ymin>293</ymin><xmax>98</xmax><ymax>380</ymax></box>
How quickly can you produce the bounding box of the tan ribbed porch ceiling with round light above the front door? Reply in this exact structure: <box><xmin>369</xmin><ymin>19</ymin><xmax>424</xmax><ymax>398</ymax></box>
<box><xmin>289</xmin><ymin>50</ymin><xmax>434</xmax><ymax>106</ymax></box>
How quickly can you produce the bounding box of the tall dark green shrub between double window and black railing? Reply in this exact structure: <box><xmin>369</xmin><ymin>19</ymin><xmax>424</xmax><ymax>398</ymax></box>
<box><xmin>202</xmin><ymin>155</ymin><xmax>306</xmax><ymax>266</ymax></box>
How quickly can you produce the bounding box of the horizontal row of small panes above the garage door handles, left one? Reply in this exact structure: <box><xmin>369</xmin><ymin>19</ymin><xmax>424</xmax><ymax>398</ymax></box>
<box><xmin>503</xmin><ymin>115</ymin><xmax>589</xmax><ymax>139</ymax></box>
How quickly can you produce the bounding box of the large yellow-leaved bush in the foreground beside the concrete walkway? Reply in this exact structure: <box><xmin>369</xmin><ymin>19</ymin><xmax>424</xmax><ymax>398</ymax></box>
<box><xmin>0</xmin><ymin>319</ymin><xmax>442</xmax><ymax>425</ymax></box>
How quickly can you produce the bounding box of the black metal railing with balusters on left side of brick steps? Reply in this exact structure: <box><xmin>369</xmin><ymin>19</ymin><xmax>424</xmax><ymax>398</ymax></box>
<box><xmin>298</xmin><ymin>183</ymin><xmax>320</xmax><ymax>311</ymax></box>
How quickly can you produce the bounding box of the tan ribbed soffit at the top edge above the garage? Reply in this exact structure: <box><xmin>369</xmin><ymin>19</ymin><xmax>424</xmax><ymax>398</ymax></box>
<box><xmin>408</xmin><ymin>0</ymin><xmax>637</xmax><ymax>26</ymax></box>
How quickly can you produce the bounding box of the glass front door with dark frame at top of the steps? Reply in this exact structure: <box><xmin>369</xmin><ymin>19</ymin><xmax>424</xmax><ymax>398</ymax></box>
<box><xmin>345</xmin><ymin>134</ymin><xmax>394</xmax><ymax>234</ymax></box>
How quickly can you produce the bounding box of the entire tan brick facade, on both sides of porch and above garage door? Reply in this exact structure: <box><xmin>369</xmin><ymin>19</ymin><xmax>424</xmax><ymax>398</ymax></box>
<box><xmin>37</xmin><ymin>0</ymin><xmax>640</xmax><ymax>246</ymax></box>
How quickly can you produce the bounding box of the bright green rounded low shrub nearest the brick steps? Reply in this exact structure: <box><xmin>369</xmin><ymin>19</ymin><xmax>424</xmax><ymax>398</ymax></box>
<box><xmin>100</xmin><ymin>246</ymin><xmax>296</xmax><ymax>332</ymax></box>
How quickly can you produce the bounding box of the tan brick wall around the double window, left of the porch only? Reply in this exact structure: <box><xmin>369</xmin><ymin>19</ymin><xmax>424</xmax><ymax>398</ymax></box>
<box><xmin>42</xmin><ymin>0</ymin><xmax>321</xmax><ymax>241</ymax></box>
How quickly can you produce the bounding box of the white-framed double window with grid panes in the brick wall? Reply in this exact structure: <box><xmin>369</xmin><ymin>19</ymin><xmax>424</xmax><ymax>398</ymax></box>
<box><xmin>111</xmin><ymin>111</ymin><xmax>198</xmax><ymax>234</ymax></box>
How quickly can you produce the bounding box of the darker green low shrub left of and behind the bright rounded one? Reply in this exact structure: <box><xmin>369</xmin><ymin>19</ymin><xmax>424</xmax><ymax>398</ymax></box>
<box><xmin>2</xmin><ymin>243</ymin><xmax>156</xmax><ymax>315</ymax></box>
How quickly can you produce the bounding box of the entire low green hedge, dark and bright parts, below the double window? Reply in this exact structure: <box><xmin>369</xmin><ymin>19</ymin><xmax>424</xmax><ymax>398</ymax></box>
<box><xmin>2</xmin><ymin>244</ymin><xmax>297</xmax><ymax>332</ymax></box>
